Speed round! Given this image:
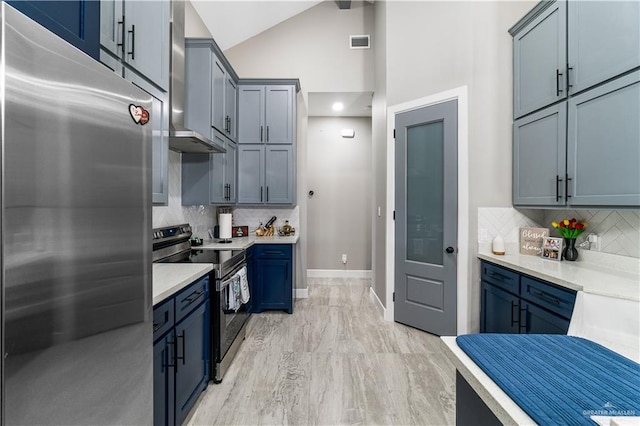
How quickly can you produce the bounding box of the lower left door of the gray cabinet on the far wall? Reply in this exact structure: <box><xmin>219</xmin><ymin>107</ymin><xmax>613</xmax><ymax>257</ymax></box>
<box><xmin>238</xmin><ymin>145</ymin><xmax>264</xmax><ymax>204</ymax></box>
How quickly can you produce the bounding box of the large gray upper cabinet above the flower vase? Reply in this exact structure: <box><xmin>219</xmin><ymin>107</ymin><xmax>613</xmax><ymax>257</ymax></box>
<box><xmin>510</xmin><ymin>1</ymin><xmax>640</xmax><ymax>208</ymax></box>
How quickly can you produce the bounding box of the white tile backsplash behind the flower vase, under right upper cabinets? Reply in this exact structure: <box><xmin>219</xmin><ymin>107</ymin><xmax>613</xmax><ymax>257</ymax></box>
<box><xmin>478</xmin><ymin>207</ymin><xmax>640</xmax><ymax>258</ymax></box>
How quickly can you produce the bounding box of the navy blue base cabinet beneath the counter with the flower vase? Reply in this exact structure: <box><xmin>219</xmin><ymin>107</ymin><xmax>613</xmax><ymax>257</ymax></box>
<box><xmin>480</xmin><ymin>261</ymin><xmax>576</xmax><ymax>334</ymax></box>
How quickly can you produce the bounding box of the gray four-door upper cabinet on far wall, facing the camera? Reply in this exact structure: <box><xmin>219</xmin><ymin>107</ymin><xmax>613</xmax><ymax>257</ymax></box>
<box><xmin>237</xmin><ymin>80</ymin><xmax>298</xmax><ymax>205</ymax></box>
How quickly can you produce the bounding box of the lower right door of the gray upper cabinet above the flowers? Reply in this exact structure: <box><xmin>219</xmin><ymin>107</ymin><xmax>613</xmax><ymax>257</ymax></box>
<box><xmin>567</xmin><ymin>71</ymin><xmax>640</xmax><ymax>207</ymax></box>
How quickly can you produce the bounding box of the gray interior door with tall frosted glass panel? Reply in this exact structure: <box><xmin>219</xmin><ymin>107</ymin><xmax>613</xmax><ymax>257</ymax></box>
<box><xmin>394</xmin><ymin>100</ymin><xmax>458</xmax><ymax>335</ymax></box>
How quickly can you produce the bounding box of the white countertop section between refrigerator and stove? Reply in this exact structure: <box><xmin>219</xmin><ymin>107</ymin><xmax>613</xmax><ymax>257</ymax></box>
<box><xmin>152</xmin><ymin>263</ymin><xmax>213</xmax><ymax>306</ymax></box>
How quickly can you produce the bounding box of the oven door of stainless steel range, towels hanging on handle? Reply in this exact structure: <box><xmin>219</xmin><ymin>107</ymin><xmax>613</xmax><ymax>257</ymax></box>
<box><xmin>212</xmin><ymin>263</ymin><xmax>249</xmax><ymax>380</ymax></box>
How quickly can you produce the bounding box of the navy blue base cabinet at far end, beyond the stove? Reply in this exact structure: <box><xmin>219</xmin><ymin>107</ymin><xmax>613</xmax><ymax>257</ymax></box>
<box><xmin>251</xmin><ymin>244</ymin><xmax>293</xmax><ymax>314</ymax></box>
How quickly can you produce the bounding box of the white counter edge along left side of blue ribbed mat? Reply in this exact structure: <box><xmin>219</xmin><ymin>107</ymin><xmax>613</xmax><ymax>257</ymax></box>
<box><xmin>440</xmin><ymin>336</ymin><xmax>536</xmax><ymax>425</ymax></box>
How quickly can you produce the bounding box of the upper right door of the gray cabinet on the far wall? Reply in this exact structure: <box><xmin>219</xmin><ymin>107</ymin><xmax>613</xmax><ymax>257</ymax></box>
<box><xmin>265</xmin><ymin>86</ymin><xmax>295</xmax><ymax>144</ymax></box>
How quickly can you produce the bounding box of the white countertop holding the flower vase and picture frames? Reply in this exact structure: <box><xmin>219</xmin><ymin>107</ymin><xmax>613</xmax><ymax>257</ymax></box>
<box><xmin>478</xmin><ymin>252</ymin><xmax>640</xmax><ymax>301</ymax></box>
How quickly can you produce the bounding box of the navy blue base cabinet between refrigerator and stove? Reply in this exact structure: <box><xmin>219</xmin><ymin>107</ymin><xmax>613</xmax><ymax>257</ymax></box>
<box><xmin>153</xmin><ymin>277</ymin><xmax>210</xmax><ymax>425</ymax></box>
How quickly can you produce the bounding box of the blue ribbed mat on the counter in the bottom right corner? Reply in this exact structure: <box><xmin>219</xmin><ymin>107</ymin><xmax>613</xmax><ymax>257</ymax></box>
<box><xmin>456</xmin><ymin>334</ymin><xmax>640</xmax><ymax>425</ymax></box>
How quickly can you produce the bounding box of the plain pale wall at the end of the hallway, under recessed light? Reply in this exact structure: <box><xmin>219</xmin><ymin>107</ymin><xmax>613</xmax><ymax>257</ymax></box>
<box><xmin>307</xmin><ymin>117</ymin><xmax>372</xmax><ymax>270</ymax></box>
